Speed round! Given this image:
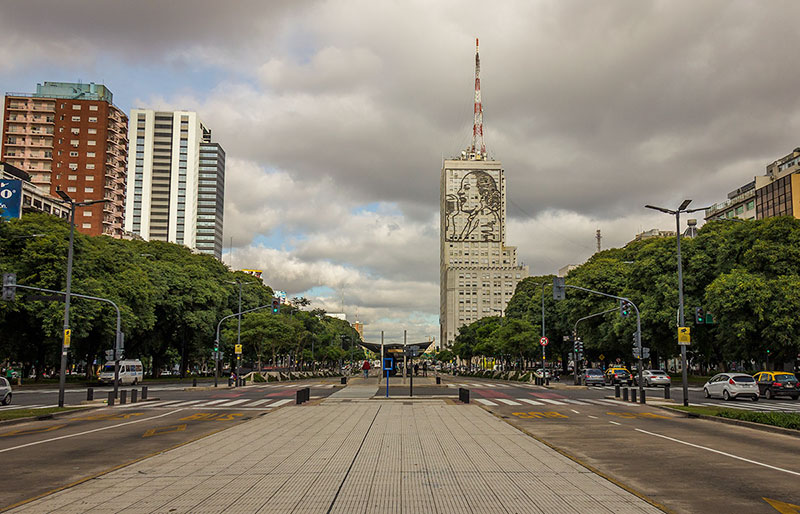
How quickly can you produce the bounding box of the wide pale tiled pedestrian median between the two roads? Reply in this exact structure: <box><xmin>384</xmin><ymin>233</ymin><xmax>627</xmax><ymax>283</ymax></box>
<box><xmin>11</xmin><ymin>400</ymin><xmax>660</xmax><ymax>514</ymax></box>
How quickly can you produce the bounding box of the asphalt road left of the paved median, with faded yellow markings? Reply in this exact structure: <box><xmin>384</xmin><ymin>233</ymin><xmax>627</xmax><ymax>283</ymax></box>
<box><xmin>0</xmin><ymin>379</ymin><xmax>342</xmax><ymax>510</ymax></box>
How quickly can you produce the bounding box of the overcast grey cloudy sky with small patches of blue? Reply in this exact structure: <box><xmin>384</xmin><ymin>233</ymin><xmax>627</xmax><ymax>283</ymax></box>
<box><xmin>0</xmin><ymin>0</ymin><xmax>800</xmax><ymax>340</ymax></box>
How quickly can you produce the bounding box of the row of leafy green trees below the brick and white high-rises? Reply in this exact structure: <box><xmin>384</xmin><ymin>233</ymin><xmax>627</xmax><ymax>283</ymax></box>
<box><xmin>0</xmin><ymin>214</ymin><xmax>358</xmax><ymax>376</ymax></box>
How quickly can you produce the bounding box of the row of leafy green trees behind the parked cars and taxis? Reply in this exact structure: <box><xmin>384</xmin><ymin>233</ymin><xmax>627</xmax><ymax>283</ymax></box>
<box><xmin>453</xmin><ymin>217</ymin><xmax>800</xmax><ymax>371</ymax></box>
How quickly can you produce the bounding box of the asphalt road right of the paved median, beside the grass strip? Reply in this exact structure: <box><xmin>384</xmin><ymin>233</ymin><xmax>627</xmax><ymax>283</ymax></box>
<box><xmin>445</xmin><ymin>377</ymin><xmax>800</xmax><ymax>513</ymax></box>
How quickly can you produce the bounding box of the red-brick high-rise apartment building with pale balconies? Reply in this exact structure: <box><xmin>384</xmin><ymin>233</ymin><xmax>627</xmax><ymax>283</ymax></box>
<box><xmin>2</xmin><ymin>82</ymin><xmax>128</xmax><ymax>237</ymax></box>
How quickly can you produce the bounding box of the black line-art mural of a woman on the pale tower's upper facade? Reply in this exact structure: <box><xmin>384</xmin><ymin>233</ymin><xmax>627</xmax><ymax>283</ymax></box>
<box><xmin>445</xmin><ymin>170</ymin><xmax>503</xmax><ymax>242</ymax></box>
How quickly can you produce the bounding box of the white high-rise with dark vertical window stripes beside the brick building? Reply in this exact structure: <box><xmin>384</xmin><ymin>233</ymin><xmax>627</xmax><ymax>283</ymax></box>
<box><xmin>125</xmin><ymin>109</ymin><xmax>225</xmax><ymax>258</ymax></box>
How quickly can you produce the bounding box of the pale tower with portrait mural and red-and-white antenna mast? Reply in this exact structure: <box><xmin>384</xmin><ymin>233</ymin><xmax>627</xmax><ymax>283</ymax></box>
<box><xmin>439</xmin><ymin>41</ymin><xmax>528</xmax><ymax>347</ymax></box>
